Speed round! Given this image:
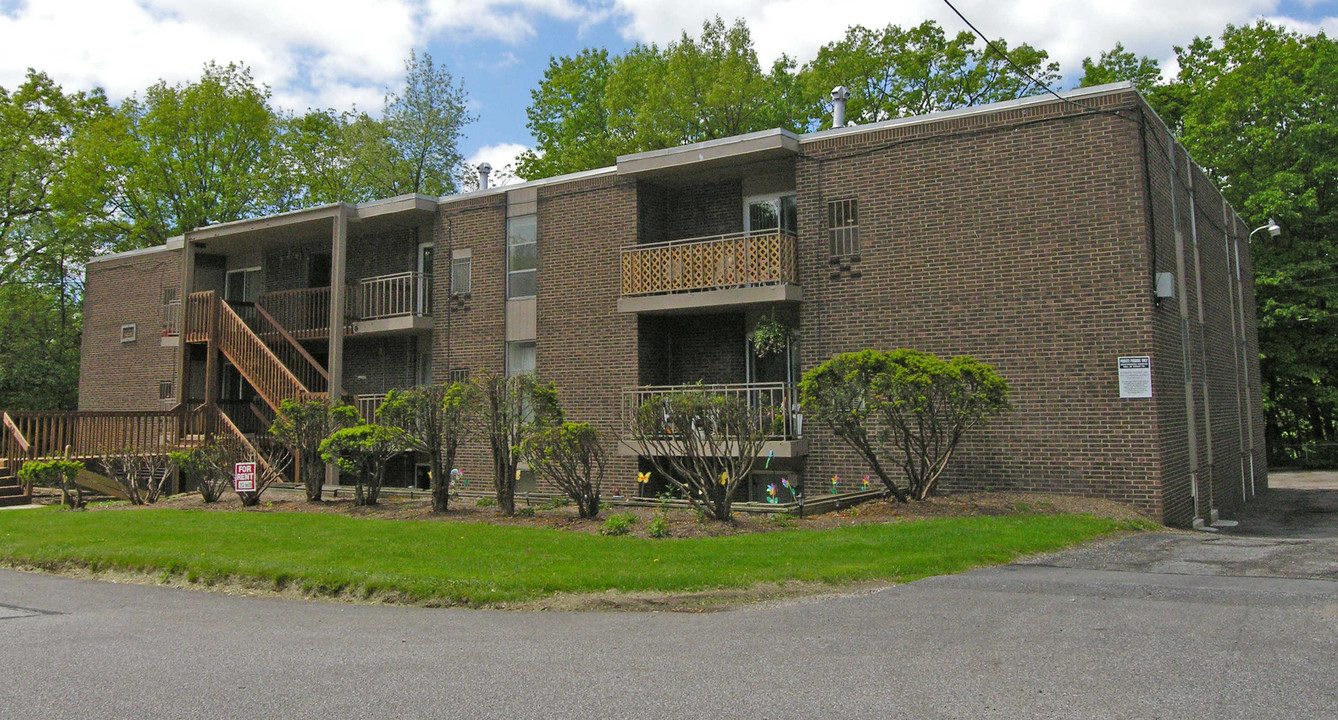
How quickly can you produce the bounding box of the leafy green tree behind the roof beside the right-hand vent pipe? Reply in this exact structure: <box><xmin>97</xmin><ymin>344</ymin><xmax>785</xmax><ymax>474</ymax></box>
<box><xmin>800</xmin><ymin>20</ymin><xmax>1060</xmax><ymax>127</ymax></box>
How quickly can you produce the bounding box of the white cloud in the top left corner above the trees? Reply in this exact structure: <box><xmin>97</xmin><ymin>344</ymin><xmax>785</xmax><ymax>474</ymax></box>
<box><xmin>0</xmin><ymin>0</ymin><xmax>421</xmax><ymax>110</ymax></box>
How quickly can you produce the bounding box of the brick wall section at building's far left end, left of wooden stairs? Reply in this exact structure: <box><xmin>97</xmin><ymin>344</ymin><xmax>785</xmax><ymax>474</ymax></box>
<box><xmin>79</xmin><ymin>249</ymin><xmax>181</xmax><ymax>411</ymax></box>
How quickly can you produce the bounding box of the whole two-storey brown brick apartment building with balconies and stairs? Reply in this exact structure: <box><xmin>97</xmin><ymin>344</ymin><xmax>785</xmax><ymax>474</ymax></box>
<box><xmin>80</xmin><ymin>84</ymin><xmax>1267</xmax><ymax>525</ymax></box>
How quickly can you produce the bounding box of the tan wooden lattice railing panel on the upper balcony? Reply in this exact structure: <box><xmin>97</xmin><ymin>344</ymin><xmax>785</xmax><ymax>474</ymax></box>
<box><xmin>622</xmin><ymin>230</ymin><xmax>796</xmax><ymax>294</ymax></box>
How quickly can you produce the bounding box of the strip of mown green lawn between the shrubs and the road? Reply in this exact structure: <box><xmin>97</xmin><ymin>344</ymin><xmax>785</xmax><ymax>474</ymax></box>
<box><xmin>0</xmin><ymin>509</ymin><xmax>1131</xmax><ymax>606</ymax></box>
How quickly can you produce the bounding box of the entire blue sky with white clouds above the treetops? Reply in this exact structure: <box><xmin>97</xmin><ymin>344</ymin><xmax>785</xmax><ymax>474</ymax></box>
<box><xmin>0</xmin><ymin>0</ymin><xmax>1338</xmax><ymax>180</ymax></box>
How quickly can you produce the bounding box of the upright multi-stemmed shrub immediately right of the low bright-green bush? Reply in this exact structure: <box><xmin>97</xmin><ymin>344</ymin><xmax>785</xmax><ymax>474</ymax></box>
<box><xmin>376</xmin><ymin>383</ymin><xmax>479</xmax><ymax>513</ymax></box>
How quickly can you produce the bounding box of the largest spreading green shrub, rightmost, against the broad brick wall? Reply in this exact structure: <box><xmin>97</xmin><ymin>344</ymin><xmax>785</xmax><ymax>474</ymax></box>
<box><xmin>800</xmin><ymin>349</ymin><xmax>1009</xmax><ymax>502</ymax></box>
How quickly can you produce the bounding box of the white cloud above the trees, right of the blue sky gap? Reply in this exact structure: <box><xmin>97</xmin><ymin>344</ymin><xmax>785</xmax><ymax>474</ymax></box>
<box><xmin>614</xmin><ymin>0</ymin><xmax>1305</xmax><ymax>75</ymax></box>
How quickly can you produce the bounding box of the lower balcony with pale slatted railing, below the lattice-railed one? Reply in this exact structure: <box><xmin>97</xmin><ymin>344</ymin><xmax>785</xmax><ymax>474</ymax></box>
<box><xmin>618</xmin><ymin>383</ymin><xmax>808</xmax><ymax>458</ymax></box>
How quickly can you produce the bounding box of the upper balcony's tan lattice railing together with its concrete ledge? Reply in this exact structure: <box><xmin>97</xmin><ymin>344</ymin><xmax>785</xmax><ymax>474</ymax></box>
<box><xmin>618</xmin><ymin>230</ymin><xmax>803</xmax><ymax>313</ymax></box>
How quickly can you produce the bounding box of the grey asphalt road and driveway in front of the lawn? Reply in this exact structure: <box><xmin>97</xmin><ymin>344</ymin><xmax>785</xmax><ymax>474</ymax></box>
<box><xmin>0</xmin><ymin>476</ymin><xmax>1338</xmax><ymax>720</ymax></box>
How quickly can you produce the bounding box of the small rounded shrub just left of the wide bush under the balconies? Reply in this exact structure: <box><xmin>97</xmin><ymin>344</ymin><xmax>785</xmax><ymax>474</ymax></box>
<box><xmin>520</xmin><ymin>423</ymin><xmax>606</xmax><ymax>518</ymax></box>
